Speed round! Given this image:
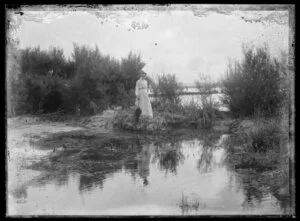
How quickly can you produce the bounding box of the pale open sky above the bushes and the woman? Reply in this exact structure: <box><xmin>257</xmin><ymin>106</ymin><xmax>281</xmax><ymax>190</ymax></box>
<box><xmin>15</xmin><ymin>5</ymin><xmax>289</xmax><ymax>84</ymax></box>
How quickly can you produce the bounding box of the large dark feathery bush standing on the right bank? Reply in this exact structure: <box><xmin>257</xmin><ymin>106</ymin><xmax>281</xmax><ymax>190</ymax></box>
<box><xmin>223</xmin><ymin>43</ymin><xmax>288</xmax><ymax>116</ymax></box>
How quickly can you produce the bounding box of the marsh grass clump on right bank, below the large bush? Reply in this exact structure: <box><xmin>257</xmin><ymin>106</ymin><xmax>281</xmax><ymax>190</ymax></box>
<box><xmin>225</xmin><ymin>118</ymin><xmax>288</xmax><ymax>171</ymax></box>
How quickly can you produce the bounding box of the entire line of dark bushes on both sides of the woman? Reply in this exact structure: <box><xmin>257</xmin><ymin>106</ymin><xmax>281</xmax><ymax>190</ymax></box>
<box><xmin>6</xmin><ymin>44</ymin><xmax>291</xmax><ymax>119</ymax></box>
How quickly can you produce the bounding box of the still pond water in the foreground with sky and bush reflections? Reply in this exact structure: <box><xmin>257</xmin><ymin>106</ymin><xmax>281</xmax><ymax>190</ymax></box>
<box><xmin>9</xmin><ymin>133</ymin><xmax>288</xmax><ymax>215</ymax></box>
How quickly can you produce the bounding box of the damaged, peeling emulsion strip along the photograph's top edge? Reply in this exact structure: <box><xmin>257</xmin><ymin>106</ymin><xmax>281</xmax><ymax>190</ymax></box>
<box><xmin>9</xmin><ymin>5</ymin><xmax>289</xmax><ymax>34</ymax></box>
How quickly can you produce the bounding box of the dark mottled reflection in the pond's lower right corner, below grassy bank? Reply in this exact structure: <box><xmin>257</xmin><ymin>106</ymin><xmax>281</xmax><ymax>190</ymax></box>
<box><xmin>224</xmin><ymin>136</ymin><xmax>291</xmax><ymax>213</ymax></box>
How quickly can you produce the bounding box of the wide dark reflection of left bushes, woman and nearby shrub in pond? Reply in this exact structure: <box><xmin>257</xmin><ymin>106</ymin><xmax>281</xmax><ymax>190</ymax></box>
<box><xmin>28</xmin><ymin>132</ymin><xmax>209</xmax><ymax>191</ymax></box>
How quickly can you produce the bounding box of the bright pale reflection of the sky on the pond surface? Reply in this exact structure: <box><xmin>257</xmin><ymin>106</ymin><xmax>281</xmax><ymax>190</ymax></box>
<box><xmin>8</xmin><ymin>136</ymin><xmax>286</xmax><ymax>215</ymax></box>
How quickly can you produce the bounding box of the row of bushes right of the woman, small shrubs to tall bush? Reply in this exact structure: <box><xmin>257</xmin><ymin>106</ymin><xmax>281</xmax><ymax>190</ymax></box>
<box><xmin>154</xmin><ymin>44</ymin><xmax>292</xmax><ymax>120</ymax></box>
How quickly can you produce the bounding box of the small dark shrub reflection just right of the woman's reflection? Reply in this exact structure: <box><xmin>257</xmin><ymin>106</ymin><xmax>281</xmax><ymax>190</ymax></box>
<box><xmin>153</xmin><ymin>142</ymin><xmax>184</xmax><ymax>174</ymax></box>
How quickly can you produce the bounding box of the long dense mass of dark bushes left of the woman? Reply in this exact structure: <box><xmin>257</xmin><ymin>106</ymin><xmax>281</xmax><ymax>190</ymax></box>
<box><xmin>7</xmin><ymin>44</ymin><xmax>145</xmax><ymax>116</ymax></box>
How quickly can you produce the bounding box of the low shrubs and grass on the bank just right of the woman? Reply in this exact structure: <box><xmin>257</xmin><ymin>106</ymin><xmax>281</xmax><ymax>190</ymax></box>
<box><xmin>152</xmin><ymin>74</ymin><xmax>219</xmax><ymax>129</ymax></box>
